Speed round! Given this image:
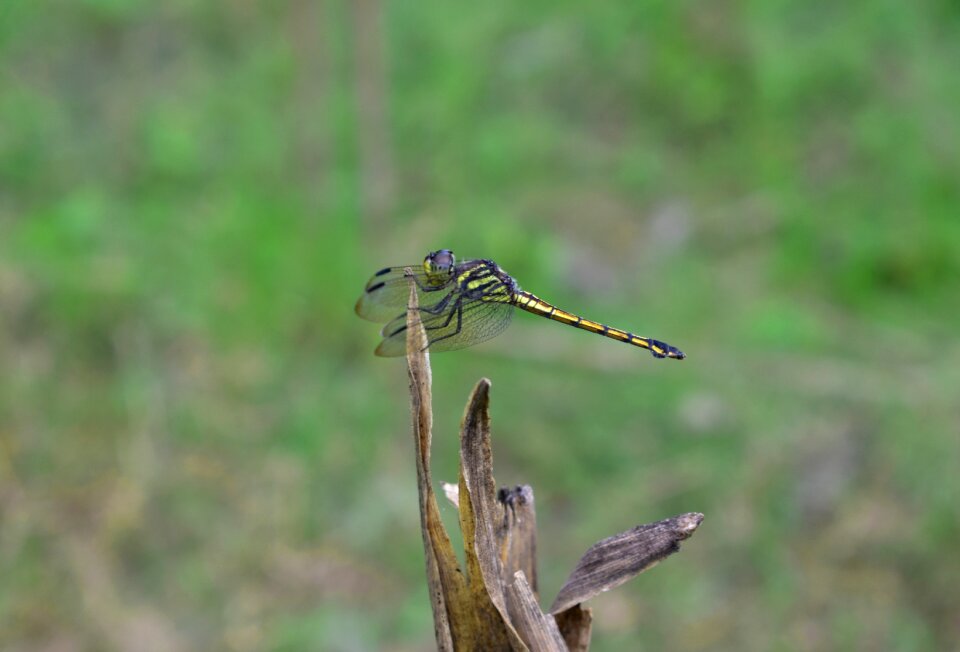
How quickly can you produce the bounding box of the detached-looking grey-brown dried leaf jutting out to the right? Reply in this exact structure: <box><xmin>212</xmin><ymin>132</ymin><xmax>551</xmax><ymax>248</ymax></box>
<box><xmin>550</xmin><ymin>513</ymin><xmax>703</xmax><ymax>614</ymax></box>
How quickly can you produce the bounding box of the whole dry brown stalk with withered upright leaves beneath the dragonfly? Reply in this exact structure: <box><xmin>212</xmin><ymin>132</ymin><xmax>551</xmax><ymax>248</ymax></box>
<box><xmin>407</xmin><ymin>281</ymin><xmax>703</xmax><ymax>652</ymax></box>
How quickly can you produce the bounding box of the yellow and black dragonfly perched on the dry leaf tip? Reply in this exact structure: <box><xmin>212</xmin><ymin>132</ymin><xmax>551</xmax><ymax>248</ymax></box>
<box><xmin>356</xmin><ymin>249</ymin><xmax>686</xmax><ymax>360</ymax></box>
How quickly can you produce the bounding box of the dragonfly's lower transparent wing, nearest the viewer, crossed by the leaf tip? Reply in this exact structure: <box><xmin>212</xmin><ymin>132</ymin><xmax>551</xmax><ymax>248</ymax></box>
<box><xmin>375</xmin><ymin>300</ymin><xmax>513</xmax><ymax>357</ymax></box>
